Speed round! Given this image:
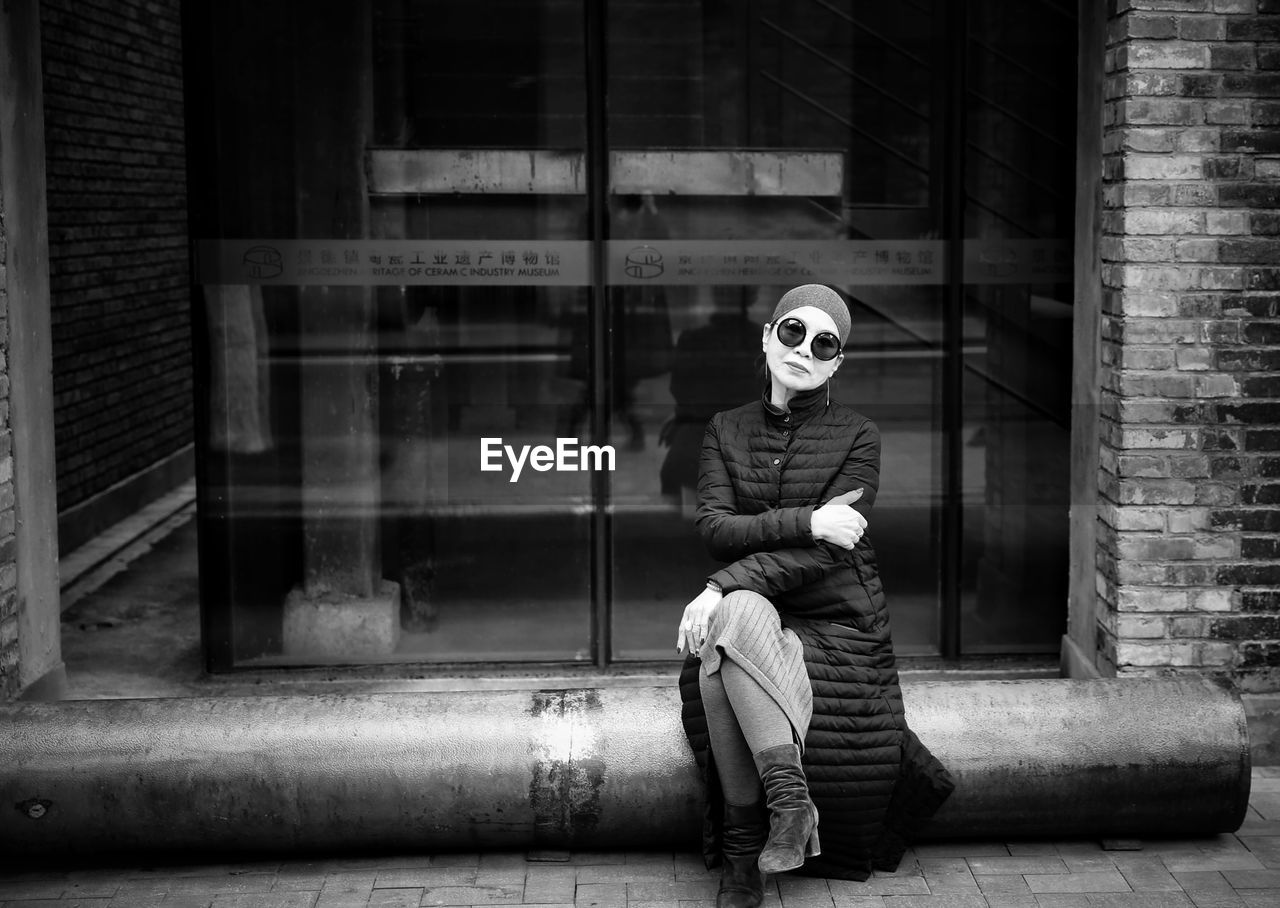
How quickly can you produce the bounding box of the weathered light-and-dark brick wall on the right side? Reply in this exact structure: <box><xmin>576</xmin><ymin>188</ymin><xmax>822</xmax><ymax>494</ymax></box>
<box><xmin>1097</xmin><ymin>0</ymin><xmax>1280</xmax><ymax>692</ymax></box>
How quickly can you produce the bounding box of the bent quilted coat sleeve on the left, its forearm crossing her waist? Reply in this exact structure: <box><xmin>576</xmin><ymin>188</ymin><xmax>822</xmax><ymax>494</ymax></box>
<box><xmin>694</xmin><ymin>415</ymin><xmax>814</xmax><ymax>561</ymax></box>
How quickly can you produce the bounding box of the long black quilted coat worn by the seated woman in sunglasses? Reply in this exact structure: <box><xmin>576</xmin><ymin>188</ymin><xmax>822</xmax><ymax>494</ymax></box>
<box><xmin>680</xmin><ymin>387</ymin><xmax>952</xmax><ymax>880</ymax></box>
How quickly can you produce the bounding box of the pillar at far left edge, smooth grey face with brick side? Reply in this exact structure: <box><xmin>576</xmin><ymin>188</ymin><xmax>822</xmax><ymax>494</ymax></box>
<box><xmin>0</xmin><ymin>0</ymin><xmax>65</xmax><ymax>699</ymax></box>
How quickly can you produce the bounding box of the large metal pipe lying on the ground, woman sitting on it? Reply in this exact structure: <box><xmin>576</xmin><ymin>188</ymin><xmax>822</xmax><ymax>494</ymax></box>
<box><xmin>0</xmin><ymin>680</ymin><xmax>1249</xmax><ymax>854</ymax></box>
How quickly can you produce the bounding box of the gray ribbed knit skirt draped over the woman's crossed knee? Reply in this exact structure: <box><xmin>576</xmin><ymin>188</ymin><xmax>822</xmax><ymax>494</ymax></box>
<box><xmin>698</xmin><ymin>589</ymin><xmax>813</xmax><ymax>749</ymax></box>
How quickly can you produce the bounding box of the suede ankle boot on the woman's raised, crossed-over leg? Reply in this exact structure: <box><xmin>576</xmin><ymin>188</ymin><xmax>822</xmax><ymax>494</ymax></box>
<box><xmin>754</xmin><ymin>744</ymin><xmax>820</xmax><ymax>873</ymax></box>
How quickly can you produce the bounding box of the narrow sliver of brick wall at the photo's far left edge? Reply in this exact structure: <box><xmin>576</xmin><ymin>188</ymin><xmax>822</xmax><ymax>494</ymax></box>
<box><xmin>0</xmin><ymin>184</ymin><xmax>18</xmax><ymax>701</ymax></box>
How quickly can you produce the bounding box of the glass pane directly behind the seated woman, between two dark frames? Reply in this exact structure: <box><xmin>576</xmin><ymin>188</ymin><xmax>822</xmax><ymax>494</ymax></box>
<box><xmin>608</xmin><ymin>0</ymin><xmax>947</xmax><ymax>658</ymax></box>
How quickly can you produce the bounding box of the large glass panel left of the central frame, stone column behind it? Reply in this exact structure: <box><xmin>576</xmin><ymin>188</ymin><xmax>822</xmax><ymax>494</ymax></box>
<box><xmin>187</xmin><ymin>0</ymin><xmax>596</xmax><ymax>669</ymax></box>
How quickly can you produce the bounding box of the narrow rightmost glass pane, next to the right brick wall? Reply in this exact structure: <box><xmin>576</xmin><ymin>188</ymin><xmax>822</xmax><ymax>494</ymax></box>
<box><xmin>961</xmin><ymin>0</ymin><xmax>1076</xmax><ymax>653</ymax></box>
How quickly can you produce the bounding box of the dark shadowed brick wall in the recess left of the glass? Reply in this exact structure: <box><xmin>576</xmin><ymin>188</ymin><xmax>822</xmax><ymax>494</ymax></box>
<box><xmin>41</xmin><ymin>0</ymin><xmax>192</xmax><ymax>511</ymax></box>
